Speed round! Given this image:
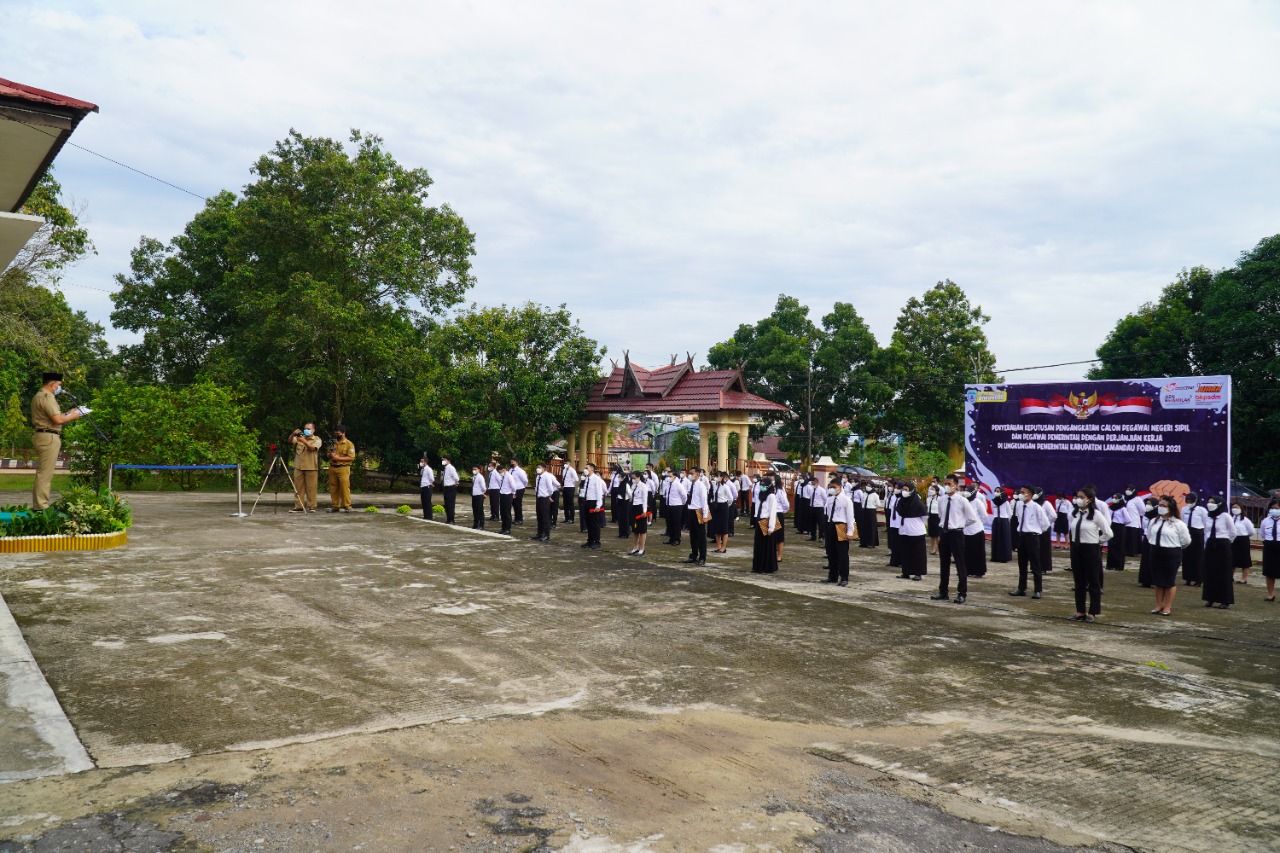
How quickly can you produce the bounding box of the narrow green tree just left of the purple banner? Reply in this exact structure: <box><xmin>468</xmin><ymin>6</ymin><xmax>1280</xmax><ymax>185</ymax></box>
<box><xmin>883</xmin><ymin>279</ymin><xmax>1000</xmax><ymax>451</ymax></box>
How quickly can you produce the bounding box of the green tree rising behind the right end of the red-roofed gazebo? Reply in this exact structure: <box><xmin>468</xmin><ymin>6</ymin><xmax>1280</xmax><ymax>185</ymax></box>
<box><xmin>707</xmin><ymin>295</ymin><xmax>887</xmax><ymax>466</ymax></box>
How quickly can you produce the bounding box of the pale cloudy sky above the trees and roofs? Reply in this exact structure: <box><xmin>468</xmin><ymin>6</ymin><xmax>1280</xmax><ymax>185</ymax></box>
<box><xmin>0</xmin><ymin>0</ymin><xmax>1280</xmax><ymax>379</ymax></box>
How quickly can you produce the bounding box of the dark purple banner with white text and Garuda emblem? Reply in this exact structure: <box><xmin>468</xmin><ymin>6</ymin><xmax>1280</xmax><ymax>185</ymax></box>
<box><xmin>965</xmin><ymin>377</ymin><xmax>1231</xmax><ymax>503</ymax></box>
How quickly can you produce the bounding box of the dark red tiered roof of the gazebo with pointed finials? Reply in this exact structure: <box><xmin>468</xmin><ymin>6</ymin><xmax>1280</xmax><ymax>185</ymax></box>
<box><xmin>586</xmin><ymin>353</ymin><xmax>788</xmax><ymax>415</ymax></box>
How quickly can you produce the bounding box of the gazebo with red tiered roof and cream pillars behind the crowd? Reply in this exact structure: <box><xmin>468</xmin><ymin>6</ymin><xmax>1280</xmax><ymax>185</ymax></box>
<box><xmin>567</xmin><ymin>353</ymin><xmax>788</xmax><ymax>470</ymax></box>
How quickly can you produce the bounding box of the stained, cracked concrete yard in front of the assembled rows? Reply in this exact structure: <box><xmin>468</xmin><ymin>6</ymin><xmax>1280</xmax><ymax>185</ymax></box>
<box><xmin>0</xmin><ymin>494</ymin><xmax>1280</xmax><ymax>852</ymax></box>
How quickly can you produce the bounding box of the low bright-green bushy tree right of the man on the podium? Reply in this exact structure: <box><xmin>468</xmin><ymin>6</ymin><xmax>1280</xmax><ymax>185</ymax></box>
<box><xmin>67</xmin><ymin>382</ymin><xmax>260</xmax><ymax>491</ymax></box>
